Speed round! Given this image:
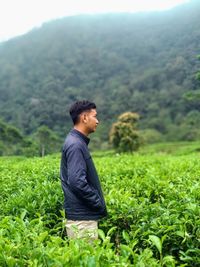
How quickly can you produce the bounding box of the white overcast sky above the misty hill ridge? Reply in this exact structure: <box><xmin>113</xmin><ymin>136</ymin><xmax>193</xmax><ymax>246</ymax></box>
<box><xmin>0</xmin><ymin>0</ymin><xmax>190</xmax><ymax>41</ymax></box>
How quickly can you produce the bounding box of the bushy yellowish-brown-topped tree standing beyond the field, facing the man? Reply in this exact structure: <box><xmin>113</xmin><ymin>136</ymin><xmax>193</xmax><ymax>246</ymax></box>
<box><xmin>109</xmin><ymin>112</ymin><xmax>141</xmax><ymax>152</ymax></box>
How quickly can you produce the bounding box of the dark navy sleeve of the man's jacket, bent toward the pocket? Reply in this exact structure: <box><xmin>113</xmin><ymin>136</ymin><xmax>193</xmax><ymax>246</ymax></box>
<box><xmin>67</xmin><ymin>146</ymin><xmax>102</xmax><ymax>209</ymax></box>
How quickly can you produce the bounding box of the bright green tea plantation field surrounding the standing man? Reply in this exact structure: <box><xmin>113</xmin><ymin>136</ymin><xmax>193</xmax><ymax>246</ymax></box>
<box><xmin>0</xmin><ymin>148</ymin><xmax>200</xmax><ymax>267</ymax></box>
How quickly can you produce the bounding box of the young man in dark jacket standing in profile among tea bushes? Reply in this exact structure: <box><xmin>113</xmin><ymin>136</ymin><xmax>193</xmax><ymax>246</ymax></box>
<box><xmin>60</xmin><ymin>101</ymin><xmax>107</xmax><ymax>239</ymax></box>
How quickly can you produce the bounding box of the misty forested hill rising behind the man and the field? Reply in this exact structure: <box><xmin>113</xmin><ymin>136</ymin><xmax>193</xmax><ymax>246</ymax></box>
<box><xmin>0</xmin><ymin>0</ymin><xmax>200</xmax><ymax>144</ymax></box>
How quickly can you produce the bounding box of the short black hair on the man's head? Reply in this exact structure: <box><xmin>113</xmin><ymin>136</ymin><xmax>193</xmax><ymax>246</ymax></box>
<box><xmin>69</xmin><ymin>100</ymin><xmax>96</xmax><ymax>124</ymax></box>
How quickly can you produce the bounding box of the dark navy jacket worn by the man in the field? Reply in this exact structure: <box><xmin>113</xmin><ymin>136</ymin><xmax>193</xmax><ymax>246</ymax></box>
<box><xmin>60</xmin><ymin>129</ymin><xmax>107</xmax><ymax>220</ymax></box>
